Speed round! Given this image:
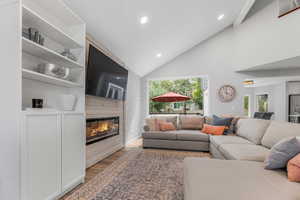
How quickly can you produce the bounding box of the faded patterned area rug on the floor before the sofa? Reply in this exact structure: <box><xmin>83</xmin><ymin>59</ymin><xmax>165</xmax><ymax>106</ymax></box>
<box><xmin>65</xmin><ymin>150</ymin><xmax>209</xmax><ymax>200</ymax></box>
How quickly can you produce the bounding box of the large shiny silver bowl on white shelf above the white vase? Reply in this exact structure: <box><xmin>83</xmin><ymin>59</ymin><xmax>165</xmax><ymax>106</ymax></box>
<box><xmin>37</xmin><ymin>63</ymin><xmax>70</xmax><ymax>79</ymax></box>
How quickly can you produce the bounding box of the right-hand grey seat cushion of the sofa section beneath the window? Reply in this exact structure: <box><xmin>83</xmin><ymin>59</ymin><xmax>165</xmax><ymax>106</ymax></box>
<box><xmin>176</xmin><ymin>130</ymin><xmax>209</xmax><ymax>142</ymax></box>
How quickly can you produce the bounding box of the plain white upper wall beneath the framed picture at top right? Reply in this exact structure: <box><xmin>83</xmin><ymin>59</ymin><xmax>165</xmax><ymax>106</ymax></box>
<box><xmin>233</xmin><ymin>0</ymin><xmax>300</xmax><ymax>69</ymax></box>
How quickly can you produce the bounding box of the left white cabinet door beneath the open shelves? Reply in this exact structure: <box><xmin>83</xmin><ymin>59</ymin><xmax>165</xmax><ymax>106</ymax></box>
<box><xmin>22</xmin><ymin>113</ymin><xmax>61</xmax><ymax>200</ymax></box>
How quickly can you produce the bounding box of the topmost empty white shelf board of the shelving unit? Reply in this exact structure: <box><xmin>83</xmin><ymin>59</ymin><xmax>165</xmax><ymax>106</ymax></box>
<box><xmin>23</xmin><ymin>5</ymin><xmax>83</xmax><ymax>49</ymax></box>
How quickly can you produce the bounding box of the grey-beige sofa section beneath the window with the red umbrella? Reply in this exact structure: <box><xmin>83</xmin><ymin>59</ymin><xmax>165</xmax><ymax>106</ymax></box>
<box><xmin>142</xmin><ymin>116</ymin><xmax>209</xmax><ymax>151</ymax></box>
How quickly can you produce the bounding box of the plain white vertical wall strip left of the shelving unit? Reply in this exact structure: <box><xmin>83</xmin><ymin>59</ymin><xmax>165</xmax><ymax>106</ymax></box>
<box><xmin>0</xmin><ymin>0</ymin><xmax>22</xmax><ymax>200</ymax></box>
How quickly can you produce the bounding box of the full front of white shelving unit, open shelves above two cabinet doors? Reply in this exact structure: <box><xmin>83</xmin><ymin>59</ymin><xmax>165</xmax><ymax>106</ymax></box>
<box><xmin>15</xmin><ymin>0</ymin><xmax>86</xmax><ymax>200</ymax></box>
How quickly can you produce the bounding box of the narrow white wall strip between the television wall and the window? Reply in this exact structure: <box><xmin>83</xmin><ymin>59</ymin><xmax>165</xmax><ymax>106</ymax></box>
<box><xmin>125</xmin><ymin>71</ymin><xmax>141</xmax><ymax>144</ymax></box>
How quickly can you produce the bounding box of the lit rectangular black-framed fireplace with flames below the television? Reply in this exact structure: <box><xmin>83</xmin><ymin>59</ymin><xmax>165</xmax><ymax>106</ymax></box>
<box><xmin>86</xmin><ymin>117</ymin><xmax>120</xmax><ymax>145</ymax></box>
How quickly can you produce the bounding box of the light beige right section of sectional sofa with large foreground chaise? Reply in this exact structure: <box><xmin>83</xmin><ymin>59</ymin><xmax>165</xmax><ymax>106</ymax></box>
<box><xmin>184</xmin><ymin>119</ymin><xmax>300</xmax><ymax>200</ymax></box>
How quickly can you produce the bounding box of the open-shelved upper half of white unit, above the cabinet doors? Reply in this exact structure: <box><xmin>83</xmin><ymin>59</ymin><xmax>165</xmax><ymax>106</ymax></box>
<box><xmin>21</xmin><ymin>0</ymin><xmax>85</xmax><ymax>112</ymax></box>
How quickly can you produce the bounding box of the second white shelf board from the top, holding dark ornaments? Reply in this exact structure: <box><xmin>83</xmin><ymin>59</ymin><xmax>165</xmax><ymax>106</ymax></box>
<box><xmin>22</xmin><ymin>37</ymin><xmax>84</xmax><ymax>69</ymax></box>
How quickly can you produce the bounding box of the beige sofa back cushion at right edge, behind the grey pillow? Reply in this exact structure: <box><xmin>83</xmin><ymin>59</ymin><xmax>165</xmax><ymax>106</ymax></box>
<box><xmin>262</xmin><ymin>121</ymin><xmax>300</xmax><ymax>148</ymax></box>
